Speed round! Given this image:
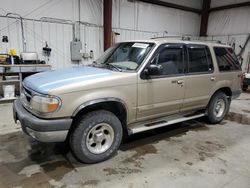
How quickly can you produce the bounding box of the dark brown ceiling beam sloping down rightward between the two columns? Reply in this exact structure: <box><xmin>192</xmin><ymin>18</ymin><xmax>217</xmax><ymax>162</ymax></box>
<box><xmin>137</xmin><ymin>0</ymin><xmax>201</xmax><ymax>14</ymax></box>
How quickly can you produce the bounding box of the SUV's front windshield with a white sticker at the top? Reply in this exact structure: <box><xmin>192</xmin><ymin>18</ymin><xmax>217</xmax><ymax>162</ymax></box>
<box><xmin>95</xmin><ymin>42</ymin><xmax>154</xmax><ymax>71</ymax></box>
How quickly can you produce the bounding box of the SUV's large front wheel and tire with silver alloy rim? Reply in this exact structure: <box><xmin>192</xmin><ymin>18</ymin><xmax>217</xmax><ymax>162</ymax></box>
<box><xmin>70</xmin><ymin>110</ymin><xmax>123</xmax><ymax>163</ymax></box>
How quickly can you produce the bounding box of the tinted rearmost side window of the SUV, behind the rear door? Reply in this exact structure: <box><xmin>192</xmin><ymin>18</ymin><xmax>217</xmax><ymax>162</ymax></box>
<box><xmin>214</xmin><ymin>47</ymin><xmax>241</xmax><ymax>71</ymax></box>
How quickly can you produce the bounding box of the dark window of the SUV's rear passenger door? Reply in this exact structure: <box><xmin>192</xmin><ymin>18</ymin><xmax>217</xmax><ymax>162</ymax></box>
<box><xmin>187</xmin><ymin>45</ymin><xmax>213</xmax><ymax>73</ymax></box>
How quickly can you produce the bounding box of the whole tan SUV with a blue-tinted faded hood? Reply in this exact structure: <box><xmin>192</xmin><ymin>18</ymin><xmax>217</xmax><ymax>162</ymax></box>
<box><xmin>14</xmin><ymin>39</ymin><xmax>242</xmax><ymax>163</ymax></box>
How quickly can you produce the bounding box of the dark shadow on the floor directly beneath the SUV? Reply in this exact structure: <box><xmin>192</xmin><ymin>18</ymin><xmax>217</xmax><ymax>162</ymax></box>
<box><xmin>26</xmin><ymin>118</ymin><xmax>209</xmax><ymax>166</ymax></box>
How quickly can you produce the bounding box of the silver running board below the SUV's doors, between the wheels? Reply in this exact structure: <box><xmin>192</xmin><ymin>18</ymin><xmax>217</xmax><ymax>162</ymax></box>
<box><xmin>129</xmin><ymin>113</ymin><xmax>205</xmax><ymax>134</ymax></box>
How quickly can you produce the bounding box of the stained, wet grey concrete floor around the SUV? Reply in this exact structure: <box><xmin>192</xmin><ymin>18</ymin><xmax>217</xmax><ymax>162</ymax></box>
<box><xmin>0</xmin><ymin>93</ymin><xmax>250</xmax><ymax>188</ymax></box>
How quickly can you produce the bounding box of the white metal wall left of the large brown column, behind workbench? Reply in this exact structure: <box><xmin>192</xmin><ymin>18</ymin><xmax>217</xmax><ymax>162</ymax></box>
<box><xmin>0</xmin><ymin>0</ymin><xmax>103</xmax><ymax>69</ymax></box>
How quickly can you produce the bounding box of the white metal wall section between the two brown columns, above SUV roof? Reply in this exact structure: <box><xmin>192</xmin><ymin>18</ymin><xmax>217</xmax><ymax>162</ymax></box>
<box><xmin>112</xmin><ymin>0</ymin><xmax>201</xmax><ymax>36</ymax></box>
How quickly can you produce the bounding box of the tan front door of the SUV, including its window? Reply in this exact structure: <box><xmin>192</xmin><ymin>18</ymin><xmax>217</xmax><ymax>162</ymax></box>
<box><xmin>137</xmin><ymin>44</ymin><xmax>185</xmax><ymax>121</ymax></box>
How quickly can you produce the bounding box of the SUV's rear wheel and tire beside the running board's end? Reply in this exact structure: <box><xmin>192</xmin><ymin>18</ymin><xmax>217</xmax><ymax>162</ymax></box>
<box><xmin>207</xmin><ymin>91</ymin><xmax>230</xmax><ymax>124</ymax></box>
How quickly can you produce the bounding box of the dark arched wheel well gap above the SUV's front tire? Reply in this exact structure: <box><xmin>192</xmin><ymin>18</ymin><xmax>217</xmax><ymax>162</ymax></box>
<box><xmin>72</xmin><ymin>101</ymin><xmax>128</xmax><ymax>135</ymax></box>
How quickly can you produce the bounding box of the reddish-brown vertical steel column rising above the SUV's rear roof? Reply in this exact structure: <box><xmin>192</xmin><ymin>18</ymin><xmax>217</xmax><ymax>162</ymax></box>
<box><xmin>200</xmin><ymin>0</ymin><xmax>211</xmax><ymax>36</ymax></box>
